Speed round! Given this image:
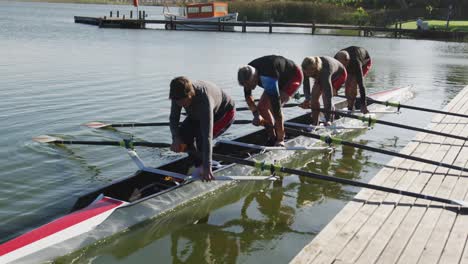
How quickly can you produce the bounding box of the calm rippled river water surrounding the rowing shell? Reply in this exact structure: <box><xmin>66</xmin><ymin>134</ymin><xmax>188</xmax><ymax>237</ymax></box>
<box><xmin>0</xmin><ymin>1</ymin><xmax>468</xmax><ymax>263</ymax></box>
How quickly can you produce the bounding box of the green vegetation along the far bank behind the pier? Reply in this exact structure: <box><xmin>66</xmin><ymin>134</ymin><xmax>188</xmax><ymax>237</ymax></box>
<box><xmin>14</xmin><ymin>0</ymin><xmax>468</xmax><ymax>29</ymax></box>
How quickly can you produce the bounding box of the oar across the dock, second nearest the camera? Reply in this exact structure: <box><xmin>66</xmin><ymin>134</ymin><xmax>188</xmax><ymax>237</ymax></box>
<box><xmin>285</xmin><ymin>127</ymin><xmax>468</xmax><ymax>172</ymax></box>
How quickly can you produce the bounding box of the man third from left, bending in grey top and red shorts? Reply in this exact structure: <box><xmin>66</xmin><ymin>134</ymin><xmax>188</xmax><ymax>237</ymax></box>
<box><xmin>300</xmin><ymin>56</ymin><xmax>347</xmax><ymax>126</ymax></box>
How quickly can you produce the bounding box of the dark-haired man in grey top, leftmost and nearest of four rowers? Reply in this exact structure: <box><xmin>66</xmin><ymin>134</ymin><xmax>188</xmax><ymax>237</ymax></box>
<box><xmin>169</xmin><ymin>76</ymin><xmax>236</xmax><ymax>181</ymax></box>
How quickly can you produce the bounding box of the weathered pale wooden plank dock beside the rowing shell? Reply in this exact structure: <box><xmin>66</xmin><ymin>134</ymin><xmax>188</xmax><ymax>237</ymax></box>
<box><xmin>291</xmin><ymin>86</ymin><xmax>468</xmax><ymax>264</ymax></box>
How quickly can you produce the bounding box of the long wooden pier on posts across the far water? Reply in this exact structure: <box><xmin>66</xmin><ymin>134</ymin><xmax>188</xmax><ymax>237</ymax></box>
<box><xmin>75</xmin><ymin>15</ymin><xmax>468</xmax><ymax>40</ymax></box>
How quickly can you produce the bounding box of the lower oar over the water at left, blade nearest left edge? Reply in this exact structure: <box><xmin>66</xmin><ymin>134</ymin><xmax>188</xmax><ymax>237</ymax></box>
<box><xmin>33</xmin><ymin>135</ymin><xmax>171</xmax><ymax>148</ymax></box>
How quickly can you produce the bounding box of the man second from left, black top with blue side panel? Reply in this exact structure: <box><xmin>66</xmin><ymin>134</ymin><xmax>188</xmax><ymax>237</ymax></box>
<box><xmin>237</xmin><ymin>55</ymin><xmax>303</xmax><ymax>146</ymax></box>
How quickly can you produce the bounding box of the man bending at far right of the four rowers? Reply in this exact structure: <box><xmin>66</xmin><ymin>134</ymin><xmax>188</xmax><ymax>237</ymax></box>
<box><xmin>335</xmin><ymin>46</ymin><xmax>372</xmax><ymax>114</ymax></box>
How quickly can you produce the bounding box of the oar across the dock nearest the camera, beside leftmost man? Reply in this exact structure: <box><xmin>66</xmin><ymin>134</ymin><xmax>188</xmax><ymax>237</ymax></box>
<box><xmin>213</xmin><ymin>154</ymin><xmax>468</xmax><ymax>207</ymax></box>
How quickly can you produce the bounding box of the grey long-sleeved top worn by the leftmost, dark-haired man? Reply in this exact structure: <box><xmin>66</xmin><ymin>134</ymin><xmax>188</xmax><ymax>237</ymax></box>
<box><xmin>169</xmin><ymin>81</ymin><xmax>234</xmax><ymax>168</ymax></box>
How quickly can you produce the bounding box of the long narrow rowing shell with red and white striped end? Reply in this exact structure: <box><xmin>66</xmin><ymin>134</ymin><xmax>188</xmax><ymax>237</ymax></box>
<box><xmin>0</xmin><ymin>87</ymin><xmax>409</xmax><ymax>263</ymax></box>
